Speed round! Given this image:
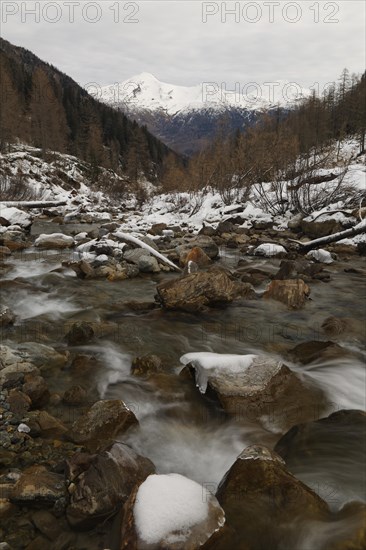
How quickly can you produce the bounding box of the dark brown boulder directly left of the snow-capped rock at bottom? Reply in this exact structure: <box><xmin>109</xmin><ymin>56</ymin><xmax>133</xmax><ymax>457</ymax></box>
<box><xmin>66</xmin><ymin>443</ymin><xmax>155</xmax><ymax>529</ymax></box>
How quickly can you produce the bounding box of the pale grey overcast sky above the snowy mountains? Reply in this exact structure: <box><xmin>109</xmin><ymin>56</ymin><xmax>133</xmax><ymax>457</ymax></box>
<box><xmin>1</xmin><ymin>0</ymin><xmax>366</xmax><ymax>89</ymax></box>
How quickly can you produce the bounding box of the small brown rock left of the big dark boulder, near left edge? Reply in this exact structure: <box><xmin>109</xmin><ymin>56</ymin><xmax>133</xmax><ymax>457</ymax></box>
<box><xmin>11</xmin><ymin>466</ymin><xmax>66</xmax><ymax>504</ymax></box>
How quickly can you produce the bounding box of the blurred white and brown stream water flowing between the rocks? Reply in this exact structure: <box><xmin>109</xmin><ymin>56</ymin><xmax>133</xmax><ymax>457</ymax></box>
<box><xmin>0</xmin><ymin>242</ymin><xmax>366</xmax><ymax>549</ymax></box>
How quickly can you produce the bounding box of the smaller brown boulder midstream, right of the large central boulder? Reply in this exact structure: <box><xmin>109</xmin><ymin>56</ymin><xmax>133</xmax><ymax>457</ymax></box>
<box><xmin>263</xmin><ymin>279</ymin><xmax>310</xmax><ymax>309</ymax></box>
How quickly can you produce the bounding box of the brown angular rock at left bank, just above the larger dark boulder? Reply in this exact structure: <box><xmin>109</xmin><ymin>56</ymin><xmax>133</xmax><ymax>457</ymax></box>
<box><xmin>69</xmin><ymin>399</ymin><xmax>138</xmax><ymax>448</ymax></box>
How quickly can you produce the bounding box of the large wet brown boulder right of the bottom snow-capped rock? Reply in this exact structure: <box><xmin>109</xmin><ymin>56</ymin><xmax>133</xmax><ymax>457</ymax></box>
<box><xmin>216</xmin><ymin>445</ymin><xmax>329</xmax><ymax>550</ymax></box>
